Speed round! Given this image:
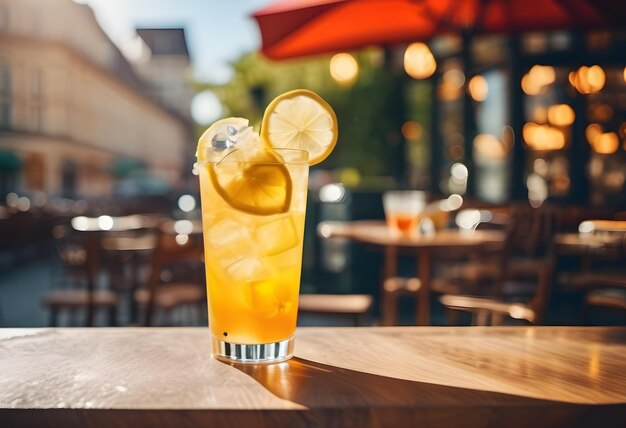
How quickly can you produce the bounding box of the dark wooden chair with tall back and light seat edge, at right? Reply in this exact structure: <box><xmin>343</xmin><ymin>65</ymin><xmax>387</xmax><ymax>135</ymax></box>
<box><xmin>440</xmin><ymin>209</ymin><xmax>556</xmax><ymax>325</ymax></box>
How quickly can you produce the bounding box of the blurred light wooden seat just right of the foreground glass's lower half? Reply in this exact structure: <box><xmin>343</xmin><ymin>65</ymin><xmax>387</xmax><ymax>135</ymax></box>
<box><xmin>298</xmin><ymin>294</ymin><xmax>373</xmax><ymax>326</ymax></box>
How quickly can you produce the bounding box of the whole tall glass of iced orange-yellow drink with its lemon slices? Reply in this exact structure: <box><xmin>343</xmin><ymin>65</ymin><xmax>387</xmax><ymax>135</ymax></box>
<box><xmin>195</xmin><ymin>90</ymin><xmax>337</xmax><ymax>363</ymax></box>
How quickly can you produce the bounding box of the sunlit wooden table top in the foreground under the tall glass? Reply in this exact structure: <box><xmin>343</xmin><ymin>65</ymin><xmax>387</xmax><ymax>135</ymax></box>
<box><xmin>0</xmin><ymin>327</ymin><xmax>626</xmax><ymax>428</ymax></box>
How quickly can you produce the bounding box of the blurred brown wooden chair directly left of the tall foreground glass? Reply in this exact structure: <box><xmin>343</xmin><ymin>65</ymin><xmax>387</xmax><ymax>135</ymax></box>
<box><xmin>134</xmin><ymin>220</ymin><xmax>206</xmax><ymax>326</ymax></box>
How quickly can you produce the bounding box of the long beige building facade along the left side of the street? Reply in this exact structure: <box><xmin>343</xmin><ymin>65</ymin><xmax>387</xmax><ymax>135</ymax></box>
<box><xmin>0</xmin><ymin>0</ymin><xmax>191</xmax><ymax>197</ymax></box>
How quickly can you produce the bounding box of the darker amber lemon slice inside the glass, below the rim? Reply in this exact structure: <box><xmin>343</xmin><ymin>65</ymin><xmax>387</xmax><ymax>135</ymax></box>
<box><xmin>207</xmin><ymin>149</ymin><xmax>292</xmax><ymax>215</ymax></box>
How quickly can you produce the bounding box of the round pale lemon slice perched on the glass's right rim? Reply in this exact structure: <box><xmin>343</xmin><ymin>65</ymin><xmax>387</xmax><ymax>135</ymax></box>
<box><xmin>261</xmin><ymin>89</ymin><xmax>337</xmax><ymax>165</ymax></box>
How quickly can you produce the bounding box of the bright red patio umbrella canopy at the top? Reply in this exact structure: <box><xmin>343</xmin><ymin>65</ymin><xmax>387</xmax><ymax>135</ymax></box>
<box><xmin>253</xmin><ymin>0</ymin><xmax>626</xmax><ymax>59</ymax></box>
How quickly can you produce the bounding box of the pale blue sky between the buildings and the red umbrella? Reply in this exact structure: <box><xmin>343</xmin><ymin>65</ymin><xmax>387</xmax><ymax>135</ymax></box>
<box><xmin>74</xmin><ymin>0</ymin><xmax>273</xmax><ymax>83</ymax></box>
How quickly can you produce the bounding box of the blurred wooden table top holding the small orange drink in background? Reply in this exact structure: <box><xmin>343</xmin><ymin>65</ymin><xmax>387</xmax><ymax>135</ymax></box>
<box><xmin>318</xmin><ymin>220</ymin><xmax>505</xmax><ymax>248</ymax></box>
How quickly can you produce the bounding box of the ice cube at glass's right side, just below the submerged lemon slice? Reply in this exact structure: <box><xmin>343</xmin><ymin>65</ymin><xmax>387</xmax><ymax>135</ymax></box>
<box><xmin>252</xmin><ymin>215</ymin><xmax>301</xmax><ymax>256</ymax></box>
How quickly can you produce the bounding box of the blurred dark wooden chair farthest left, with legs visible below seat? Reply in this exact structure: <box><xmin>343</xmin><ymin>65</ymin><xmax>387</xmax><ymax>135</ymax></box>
<box><xmin>42</xmin><ymin>226</ymin><xmax>118</xmax><ymax>327</ymax></box>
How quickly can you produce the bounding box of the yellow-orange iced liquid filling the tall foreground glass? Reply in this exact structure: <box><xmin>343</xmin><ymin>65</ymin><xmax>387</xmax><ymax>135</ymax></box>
<box><xmin>200</xmin><ymin>150</ymin><xmax>308</xmax><ymax>344</ymax></box>
